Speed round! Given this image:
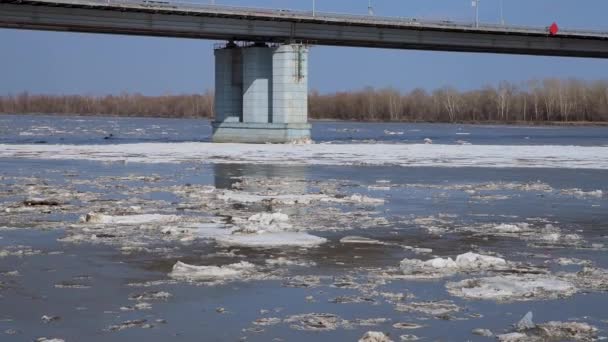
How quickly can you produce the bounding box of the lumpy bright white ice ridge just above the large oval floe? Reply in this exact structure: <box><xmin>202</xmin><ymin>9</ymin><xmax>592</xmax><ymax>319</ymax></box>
<box><xmin>400</xmin><ymin>252</ymin><xmax>508</xmax><ymax>278</ymax></box>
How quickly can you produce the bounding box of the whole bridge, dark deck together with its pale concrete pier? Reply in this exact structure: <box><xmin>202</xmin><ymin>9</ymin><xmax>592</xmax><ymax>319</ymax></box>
<box><xmin>0</xmin><ymin>0</ymin><xmax>608</xmax><ymax>142</ymax></box>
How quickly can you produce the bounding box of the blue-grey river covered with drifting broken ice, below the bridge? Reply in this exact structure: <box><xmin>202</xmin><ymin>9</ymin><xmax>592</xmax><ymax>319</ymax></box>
<box><xmin>0</xmin><ymin>115</ymin><xmax>608</xmax><ymax>341</ymax></box>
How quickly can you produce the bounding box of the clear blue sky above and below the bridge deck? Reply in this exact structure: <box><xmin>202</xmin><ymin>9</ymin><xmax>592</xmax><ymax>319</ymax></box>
<box><xmin>0</xmin><ymin>0</ymin><xmax>608</xmax><ymax>95</ymax></box>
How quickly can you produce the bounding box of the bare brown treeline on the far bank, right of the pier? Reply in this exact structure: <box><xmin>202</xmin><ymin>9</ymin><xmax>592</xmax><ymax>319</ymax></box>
<box><xmin>310</xmin><ymin>79</ymin><xmax>608</xmax><ymax>122</ymax></box>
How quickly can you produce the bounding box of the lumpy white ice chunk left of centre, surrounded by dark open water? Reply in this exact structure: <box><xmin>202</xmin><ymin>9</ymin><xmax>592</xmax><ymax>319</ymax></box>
<box><xmin>169</xmin><ymin>261</ymin><xmax>256</xmax><ymax>282</ymax></box>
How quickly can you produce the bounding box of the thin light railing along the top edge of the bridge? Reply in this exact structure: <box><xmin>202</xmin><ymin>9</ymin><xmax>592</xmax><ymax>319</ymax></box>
<box><xmin>29</xmin><ymin>0</ymin><xmax>608</xmax><ymax>38</ymax></box>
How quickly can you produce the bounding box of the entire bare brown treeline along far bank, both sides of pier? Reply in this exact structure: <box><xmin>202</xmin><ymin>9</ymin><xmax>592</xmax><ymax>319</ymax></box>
<box><xmin>0</xmin><ymin>79</ymin><xmax>608</xmax><ymax>122</ymax></box>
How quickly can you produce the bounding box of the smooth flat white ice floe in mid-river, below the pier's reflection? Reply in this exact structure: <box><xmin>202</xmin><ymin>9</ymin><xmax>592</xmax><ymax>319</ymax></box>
<box><xmin>215</xmin><ymin>232</ymin><xmax>327</xmax><ymax>248</ymax></box>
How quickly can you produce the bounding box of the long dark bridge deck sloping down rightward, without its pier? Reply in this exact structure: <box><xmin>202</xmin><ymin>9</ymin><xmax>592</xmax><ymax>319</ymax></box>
<box><xmin>0</xmin><ymin>0</ymin><xmax>608</xmax><ymax>58</ymax></box>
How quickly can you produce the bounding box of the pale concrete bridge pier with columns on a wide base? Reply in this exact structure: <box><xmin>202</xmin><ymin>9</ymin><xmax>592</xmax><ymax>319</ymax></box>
<box><xmin>212</xmin><ymin>43</ymin><xmax>311</xmax><ymax>143</ymax></box>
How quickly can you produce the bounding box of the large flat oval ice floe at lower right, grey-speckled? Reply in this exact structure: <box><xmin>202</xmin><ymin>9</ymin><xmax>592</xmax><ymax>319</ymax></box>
<box><xmin>446</xmin><ymin>275</ymin><xmax>577</xmax><ymax>301</ymax></box>
